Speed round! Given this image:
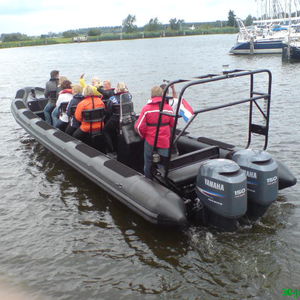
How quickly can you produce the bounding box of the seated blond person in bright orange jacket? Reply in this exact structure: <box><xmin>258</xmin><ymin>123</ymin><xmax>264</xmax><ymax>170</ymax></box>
<box><xmin>73</xmin><ymin>85</ymin><xmax>105</xmax><ymax>141</ymax></box>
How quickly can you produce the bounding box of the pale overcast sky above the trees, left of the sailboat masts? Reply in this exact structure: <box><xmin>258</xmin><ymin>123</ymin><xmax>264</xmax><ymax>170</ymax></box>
<box><xmin>0</xmin><ymin>0</ymin><xmax>256</xmax><ymax>35</ymax></box>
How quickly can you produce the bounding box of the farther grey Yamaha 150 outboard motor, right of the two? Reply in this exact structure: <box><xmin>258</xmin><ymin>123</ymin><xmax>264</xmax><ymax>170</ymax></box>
<box><xmin>232</xmin><ymin>149</ymin><xmax>278</xmax><ymax>218</ymax></box>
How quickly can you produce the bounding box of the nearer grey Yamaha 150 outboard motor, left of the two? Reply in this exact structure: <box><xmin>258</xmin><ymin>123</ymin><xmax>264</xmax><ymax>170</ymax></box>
<box><xmin>196</xmin><ymin>159</ymin><xmax>247</xmax><ymax>231</ymax></box>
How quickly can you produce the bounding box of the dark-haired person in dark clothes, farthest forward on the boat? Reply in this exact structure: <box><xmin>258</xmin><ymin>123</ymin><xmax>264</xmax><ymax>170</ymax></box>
<box><xmin>44</xmin><ymin>70</ymin><xmax>59</xmax><ymax>125</ymax></box>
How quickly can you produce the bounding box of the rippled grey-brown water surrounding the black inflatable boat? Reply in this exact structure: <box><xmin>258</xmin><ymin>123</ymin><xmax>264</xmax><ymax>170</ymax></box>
<box><xmin>0</xmin><ymin>35</ymin><xmax>300</xmax><ymax>300</ymax></box>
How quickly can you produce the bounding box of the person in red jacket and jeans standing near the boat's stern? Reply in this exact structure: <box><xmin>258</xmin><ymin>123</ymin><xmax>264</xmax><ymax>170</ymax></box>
<box><xmin>135</xmin><ymin>86</ymin><xmax>175</xmax><ymax>179</ymax></box>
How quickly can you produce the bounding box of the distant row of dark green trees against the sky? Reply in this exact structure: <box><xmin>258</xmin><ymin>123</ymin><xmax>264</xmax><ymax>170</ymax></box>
<box><xmin>0</xmin><ymin>10</ymin><xmax>255</xmax><ymax>42</ymax></box>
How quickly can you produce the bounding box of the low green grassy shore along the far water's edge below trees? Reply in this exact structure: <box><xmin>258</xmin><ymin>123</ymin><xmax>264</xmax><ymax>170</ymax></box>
<box><xmin>0</xmin><ymin>27</ymin><xmax>238</xmax><ymax>49</ymax></box>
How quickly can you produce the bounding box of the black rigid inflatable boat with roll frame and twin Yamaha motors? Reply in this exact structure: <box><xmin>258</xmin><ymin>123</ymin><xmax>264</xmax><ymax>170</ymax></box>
<box><xmin>11</xmin><ymin>70</ymin><xmax>296</xmax><ymax>230</ymax></box>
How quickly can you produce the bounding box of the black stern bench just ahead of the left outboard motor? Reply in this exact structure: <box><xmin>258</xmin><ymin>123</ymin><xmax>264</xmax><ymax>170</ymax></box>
<box><xmin>167</xmin><ymin>146</ymin><xmax>220</xmax><ymax>186</ymax></box>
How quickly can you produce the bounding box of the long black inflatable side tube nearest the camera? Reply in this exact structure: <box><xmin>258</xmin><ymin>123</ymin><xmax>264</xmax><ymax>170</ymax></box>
<box><xmin>11</xmin><ymin>88</ymin><xmax>187</xmax><ymax>227</ymax></box>
